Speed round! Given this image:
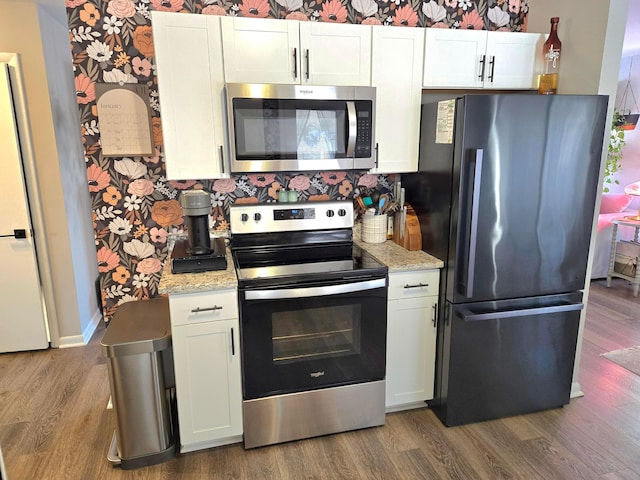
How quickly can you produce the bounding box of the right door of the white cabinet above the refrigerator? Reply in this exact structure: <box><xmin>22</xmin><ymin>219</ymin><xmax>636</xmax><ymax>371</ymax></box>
<box><xmin>485</xmin><ymin>32</ymin><xmax>544</xmax><ymax>89</ymax></box>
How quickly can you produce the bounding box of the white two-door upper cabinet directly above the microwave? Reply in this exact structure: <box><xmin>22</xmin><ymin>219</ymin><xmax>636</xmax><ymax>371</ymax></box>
<box><xmin>221</xmin><ymin>17</ymin><xmax>371</xmax><ymax>86</ymax></box>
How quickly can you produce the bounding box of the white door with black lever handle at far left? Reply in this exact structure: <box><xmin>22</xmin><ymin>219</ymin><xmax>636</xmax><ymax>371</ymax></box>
<box><xmin>0</xmin><ymin>63</ymin><xmax>49</xmax><ymax>352</ymax></box>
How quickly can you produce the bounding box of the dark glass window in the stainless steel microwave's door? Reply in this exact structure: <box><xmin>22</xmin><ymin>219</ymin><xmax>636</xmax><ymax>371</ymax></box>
<box><xmin>233</xmin><ymin>98</ymin><xmax>348</xmax><ymax>160</ymax></box>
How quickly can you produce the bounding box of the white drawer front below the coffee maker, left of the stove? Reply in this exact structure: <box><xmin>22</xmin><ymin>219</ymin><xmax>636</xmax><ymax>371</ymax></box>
<box><xmin>169</xmin><ymin>289</ymin><xmax>238</xmax><ymax>325</ymax></box>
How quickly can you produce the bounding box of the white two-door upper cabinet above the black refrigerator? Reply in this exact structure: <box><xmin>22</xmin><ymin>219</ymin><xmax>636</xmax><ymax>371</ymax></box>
<box><xmin>423</xmin><ymin>28</ymin><xmax>544</xmax><ymax>89</ymax></box>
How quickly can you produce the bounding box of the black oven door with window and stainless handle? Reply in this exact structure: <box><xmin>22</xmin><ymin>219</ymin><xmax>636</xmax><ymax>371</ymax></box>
<box><xmin>240</xmin><ymin>278</ymin><xmax>387</xmax><ymax>400</ymax></box>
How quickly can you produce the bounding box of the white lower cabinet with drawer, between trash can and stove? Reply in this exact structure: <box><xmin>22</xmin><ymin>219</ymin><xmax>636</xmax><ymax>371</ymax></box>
<box><xmin>169</xmin><ymin>290</ymin><xmax>242</xmax><ymax>452</ymax></box>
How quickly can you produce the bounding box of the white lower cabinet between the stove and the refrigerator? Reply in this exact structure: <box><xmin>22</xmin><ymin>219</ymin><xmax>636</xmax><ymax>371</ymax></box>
<box><xmin>386</xmin><ymin>270</ymin><xmax>440</xmax><ymax>411</ymax></box>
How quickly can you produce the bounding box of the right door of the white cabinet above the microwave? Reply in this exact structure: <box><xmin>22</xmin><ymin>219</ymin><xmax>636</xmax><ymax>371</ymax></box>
<box><xmin>300</xmin><ymin>22</ymin><xmax>371</xmax><ymax>86</ymax></box>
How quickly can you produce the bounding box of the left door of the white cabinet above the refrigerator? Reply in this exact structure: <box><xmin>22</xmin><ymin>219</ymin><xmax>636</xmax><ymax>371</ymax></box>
<box><xmin>423</xmin><ymin>28</ymin><xmax>488</xmax><ymax>88</ymax></box>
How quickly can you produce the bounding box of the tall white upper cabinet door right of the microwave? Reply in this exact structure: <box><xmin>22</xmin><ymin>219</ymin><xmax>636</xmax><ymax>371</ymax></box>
<box><xmin>371</xmin><ymin>26</ymin><xmax>424</xmax><ymax>173</ymax></box>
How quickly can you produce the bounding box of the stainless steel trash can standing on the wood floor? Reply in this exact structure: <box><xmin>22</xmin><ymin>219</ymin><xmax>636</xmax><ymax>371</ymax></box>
<box><xmin>102</xmin><ymin>298</ymin><xmax>177</xmax><ymax>469</ymax></box>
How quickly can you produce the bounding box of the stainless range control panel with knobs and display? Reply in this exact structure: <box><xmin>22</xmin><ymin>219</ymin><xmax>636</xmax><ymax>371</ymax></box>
<box><xmin>229</xmin><ymin>200</ymin><xmax>354</xmax><ymax>234</ymax></box>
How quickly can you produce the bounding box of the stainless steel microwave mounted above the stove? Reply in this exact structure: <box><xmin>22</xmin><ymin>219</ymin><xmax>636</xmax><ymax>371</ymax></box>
<box><xmin>226</xmin><ymin>83</ymin><xmax>376</xmax><ymax>173</ymax></box>
